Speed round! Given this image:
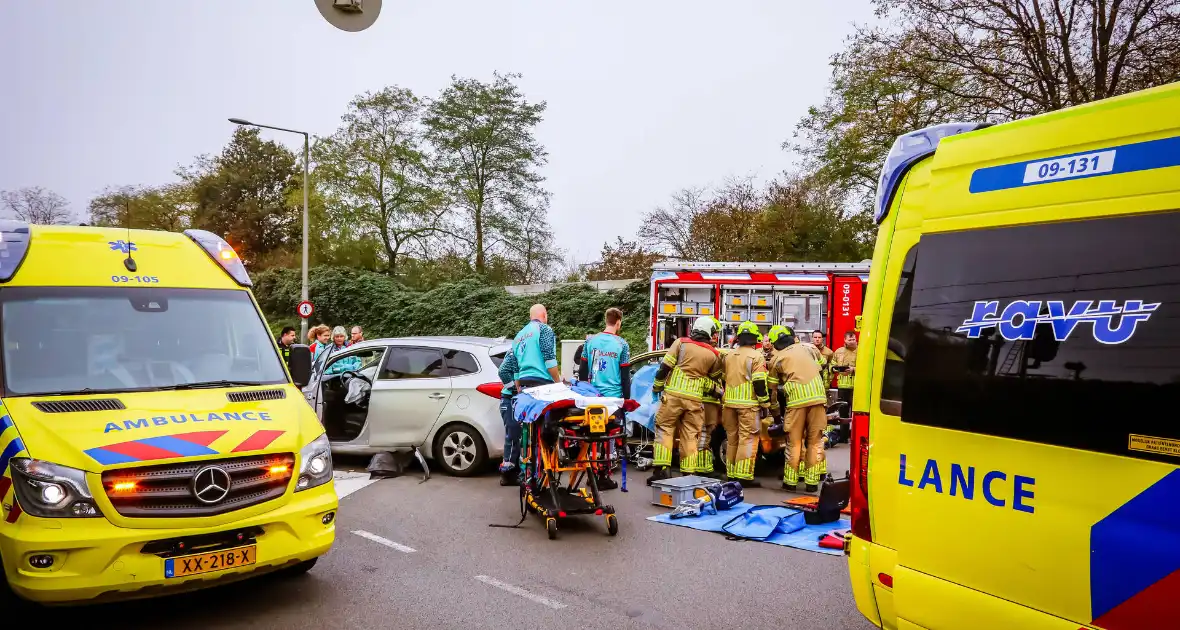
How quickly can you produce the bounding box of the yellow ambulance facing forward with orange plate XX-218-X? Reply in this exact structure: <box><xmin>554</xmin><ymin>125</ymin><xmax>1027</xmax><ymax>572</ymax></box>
<box><xmin>0</xmin><ymin>221</ymin><xmax>336</xmax><ymax>611</ymax></box>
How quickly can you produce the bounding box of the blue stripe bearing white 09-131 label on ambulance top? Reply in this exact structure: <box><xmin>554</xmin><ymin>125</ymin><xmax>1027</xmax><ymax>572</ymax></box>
<box><xmin>970</xmin><ymin>137</ymin><xmax>1180</xmax><ymax>193</ymax></box>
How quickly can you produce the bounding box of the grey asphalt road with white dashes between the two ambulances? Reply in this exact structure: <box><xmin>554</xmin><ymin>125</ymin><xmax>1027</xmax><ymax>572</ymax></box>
<box><xmin>39</xmin><ymin>447</ymin><xmax>871</xmax><ymax>630</ymax></box>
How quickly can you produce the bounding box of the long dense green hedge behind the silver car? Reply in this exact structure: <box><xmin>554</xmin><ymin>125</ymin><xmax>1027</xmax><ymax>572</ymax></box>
<box><xmin>254</xmin><ymin>267</ymin><xmax>650</xmax><ymax>353</ymax></box>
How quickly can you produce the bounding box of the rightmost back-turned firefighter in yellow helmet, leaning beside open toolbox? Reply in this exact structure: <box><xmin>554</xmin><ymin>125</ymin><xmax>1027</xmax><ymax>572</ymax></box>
<box><xmin>774</xmin><ymin>327</ymin><xmax>827</xmax><ymax>492</ymax></box>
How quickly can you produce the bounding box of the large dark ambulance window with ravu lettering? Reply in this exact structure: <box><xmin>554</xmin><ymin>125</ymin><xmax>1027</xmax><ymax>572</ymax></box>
<box><xmin>881</xmin><ymin>211</ymin><xmax>1180</xmax><ymax>462</ymax></box>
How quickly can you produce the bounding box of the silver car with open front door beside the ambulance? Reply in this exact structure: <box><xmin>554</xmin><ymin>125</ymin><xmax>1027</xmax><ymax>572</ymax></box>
<box><xmin>303</xmin><ymin>336</ymin><xmax>511</xmax><ymax>477</ymax></box>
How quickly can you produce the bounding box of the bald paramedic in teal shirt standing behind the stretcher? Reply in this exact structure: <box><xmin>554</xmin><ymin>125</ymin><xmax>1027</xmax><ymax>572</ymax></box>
<box><xmin>500</xmin><ymin>304</ymin><xmax>562</xmax><ymax>486</ymax></box>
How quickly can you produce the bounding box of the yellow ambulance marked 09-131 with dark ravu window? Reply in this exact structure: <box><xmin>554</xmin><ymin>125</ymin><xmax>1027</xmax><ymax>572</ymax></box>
<box><xmin>846</xmin><ymin>84</ymin><xmax>1180</xmax><ymax>630</ymax></box>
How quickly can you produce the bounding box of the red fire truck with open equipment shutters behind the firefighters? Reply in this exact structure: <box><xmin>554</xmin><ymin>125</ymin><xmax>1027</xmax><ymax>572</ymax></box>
<box><xmin>648</xmin><ymin>261</ymin><xmax>868</xmax><ymax>350</ymax></box>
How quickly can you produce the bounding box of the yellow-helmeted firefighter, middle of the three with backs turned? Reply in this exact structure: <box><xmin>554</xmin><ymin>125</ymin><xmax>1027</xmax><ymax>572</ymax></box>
<box><xmin>721</xmin><ymin>322</ymin><xmax>771</xmax><ymax>487</ymax></box>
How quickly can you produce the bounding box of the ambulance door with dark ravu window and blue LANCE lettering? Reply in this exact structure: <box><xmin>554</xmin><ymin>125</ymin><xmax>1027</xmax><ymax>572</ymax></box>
<box><xmin>887</xmin><ymin>210</ymin><xmax>1180</xmax><ymax>630</ymax></box>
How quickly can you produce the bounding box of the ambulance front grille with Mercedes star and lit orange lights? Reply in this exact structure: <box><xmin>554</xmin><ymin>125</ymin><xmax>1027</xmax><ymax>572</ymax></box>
<box><xmin>103</xmin><ymin>453</ymin><xmax>295</xmax><ymax>518</ymax></box>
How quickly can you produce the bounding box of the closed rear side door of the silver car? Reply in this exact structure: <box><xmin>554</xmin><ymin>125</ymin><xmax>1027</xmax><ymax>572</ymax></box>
<box><xmin>369</xmin><ymin>346</ymin><xmax>451</xmax><ymax>447</ymax></box>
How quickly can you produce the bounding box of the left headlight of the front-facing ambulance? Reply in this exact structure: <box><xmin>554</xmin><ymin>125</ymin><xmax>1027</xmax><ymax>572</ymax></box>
<box><xmin>11</xmin><ymin>458</ymin><xmax>103</xmax><ymax>518</ymax></box>
